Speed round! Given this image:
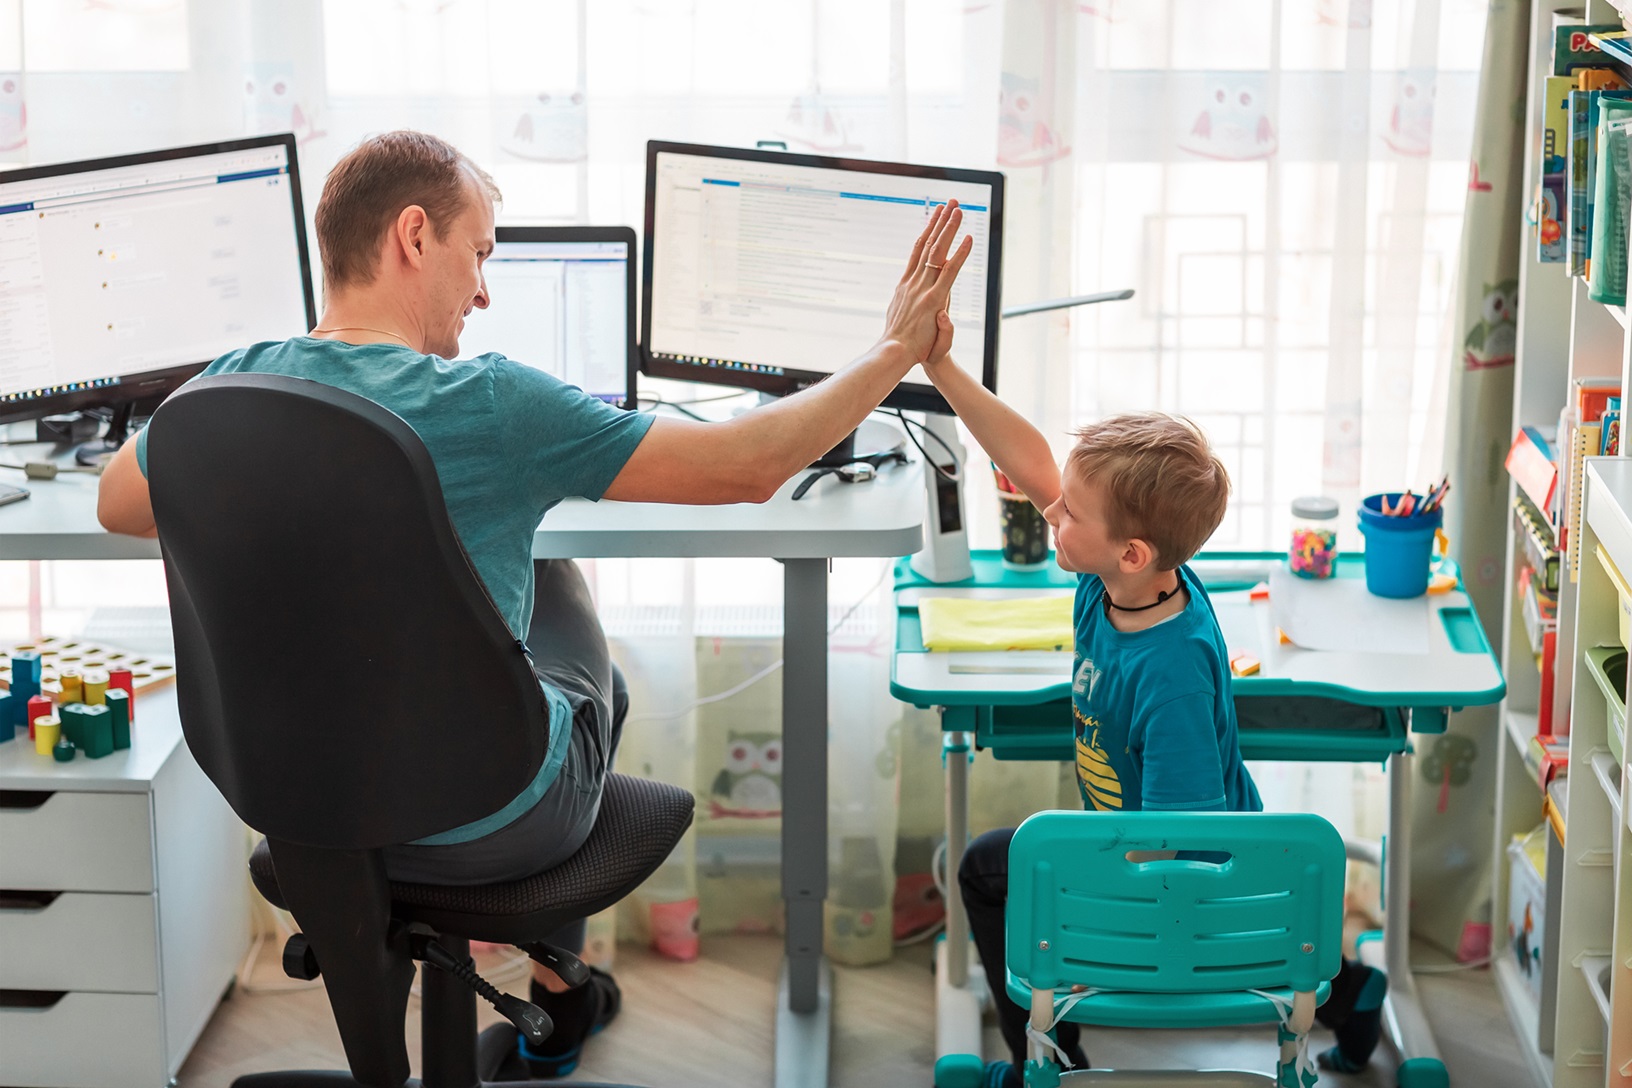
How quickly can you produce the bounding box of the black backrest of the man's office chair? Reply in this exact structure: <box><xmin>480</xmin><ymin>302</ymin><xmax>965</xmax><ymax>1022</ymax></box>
<box><xmin>147</xmin><ymin>374</ymin><xmax>548</xmax><ymax>850</ymax></box>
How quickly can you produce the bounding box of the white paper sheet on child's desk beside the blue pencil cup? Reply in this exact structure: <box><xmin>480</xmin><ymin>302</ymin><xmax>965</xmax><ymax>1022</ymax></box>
<box><xmin>1270</xmin><ymin>566</ymin><xmax>1430</xmax><ymax>654</ymax></box>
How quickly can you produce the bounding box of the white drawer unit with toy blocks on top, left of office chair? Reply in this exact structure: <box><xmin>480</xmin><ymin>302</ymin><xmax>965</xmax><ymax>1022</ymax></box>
<box><xmin>0</xmin><ymin>693</ymin><xmax>248</xmax><ymax>1088</ymax></box>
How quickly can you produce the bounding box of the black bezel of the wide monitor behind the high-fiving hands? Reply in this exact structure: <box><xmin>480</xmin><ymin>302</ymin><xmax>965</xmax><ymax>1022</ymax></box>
<box><xmin>640</xmin><ymin>140</ymin><xmax>1004</xmax><ymax>414</ymax></box>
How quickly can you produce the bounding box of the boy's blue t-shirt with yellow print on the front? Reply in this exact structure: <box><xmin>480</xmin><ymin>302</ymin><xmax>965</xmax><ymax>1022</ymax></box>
<box><xmin>1071</xmin><ymin>566</ymin><xmax>1263</xmax><ymax>812</ymax></box>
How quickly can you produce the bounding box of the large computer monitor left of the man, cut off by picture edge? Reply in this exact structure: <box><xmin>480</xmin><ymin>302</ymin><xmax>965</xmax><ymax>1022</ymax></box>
<box><xmin>0</xmin><ymin>134</ymin><xmax>317</xmax><ymax>449</ymax></box>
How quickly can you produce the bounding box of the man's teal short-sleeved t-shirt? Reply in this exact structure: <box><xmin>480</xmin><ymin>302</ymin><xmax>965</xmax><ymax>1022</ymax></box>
<box><xmin>135</xmin><ymin>336</ymin><xmax>651</xmax><ymax>845</ymax></box>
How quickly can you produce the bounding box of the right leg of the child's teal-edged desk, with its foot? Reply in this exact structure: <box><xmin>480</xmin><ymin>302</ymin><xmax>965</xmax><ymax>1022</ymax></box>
<box><xmin>1363</xmin><ymin>752</ymin><xmax>1451</xmax><ymax>1088</ymax></box>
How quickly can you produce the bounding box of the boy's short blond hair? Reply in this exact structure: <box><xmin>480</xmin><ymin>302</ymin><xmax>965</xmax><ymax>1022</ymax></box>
<box><xmin>1066</xmin><ymin>411</ymin><xmax>1229</xmax><ymax>571</ymax></box>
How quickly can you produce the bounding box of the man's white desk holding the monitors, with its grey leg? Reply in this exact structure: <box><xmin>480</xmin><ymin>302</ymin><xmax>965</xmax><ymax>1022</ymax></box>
<box><xmin>0</xmin><ymin>450</ymin><xmax>924</xmax><ymax>1088</ymax></box>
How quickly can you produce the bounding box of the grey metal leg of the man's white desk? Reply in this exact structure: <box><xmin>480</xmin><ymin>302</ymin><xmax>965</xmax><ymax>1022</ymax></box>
<box><xmin>775</xmin><ymin>559</ymin><xmax>832</xmax><ymax>1088</ymax></box>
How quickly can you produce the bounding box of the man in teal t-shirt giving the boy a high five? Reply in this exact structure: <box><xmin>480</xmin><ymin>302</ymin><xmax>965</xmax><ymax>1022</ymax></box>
<box><xmin>96</xmin><ymin>132</ymin><xmax>971</xmax><ymax>1077</ymax></box>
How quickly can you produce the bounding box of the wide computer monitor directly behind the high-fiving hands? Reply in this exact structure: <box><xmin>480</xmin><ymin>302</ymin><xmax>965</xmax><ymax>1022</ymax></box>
<box><xmin>640</xmin><ymin>142</ymin><xmax>1004</xmax><ymax>413</ymax></box>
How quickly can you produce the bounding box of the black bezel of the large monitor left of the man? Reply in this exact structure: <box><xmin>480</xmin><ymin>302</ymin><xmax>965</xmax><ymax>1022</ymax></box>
<box><xmin>0</xmin><ymin>132</ymin><xmax>317</xmax><ymax>424</ymax></box>
